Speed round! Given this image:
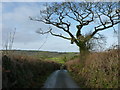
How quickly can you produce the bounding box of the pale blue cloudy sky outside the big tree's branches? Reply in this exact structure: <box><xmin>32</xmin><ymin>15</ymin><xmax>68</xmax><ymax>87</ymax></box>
<box><xmin>0</xmin><ymin>2</ymin><xmax>117</xmax><ymax>52</ymax></box>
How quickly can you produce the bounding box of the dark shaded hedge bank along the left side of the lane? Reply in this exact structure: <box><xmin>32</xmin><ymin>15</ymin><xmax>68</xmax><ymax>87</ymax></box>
<box><xmin>2</xmin><ymin>53</ymin><xmax>60</xmax><ymax>88</ymax></box>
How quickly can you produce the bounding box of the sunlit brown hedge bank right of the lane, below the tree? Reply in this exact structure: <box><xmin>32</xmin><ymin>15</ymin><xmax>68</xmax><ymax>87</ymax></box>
<box><xmin>66</xmin><ymin>50</ymin><xmax>119</xmax><ymax>88</ymax></box>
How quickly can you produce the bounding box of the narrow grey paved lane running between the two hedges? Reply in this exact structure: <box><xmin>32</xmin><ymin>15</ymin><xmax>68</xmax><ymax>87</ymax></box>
<box><xmin>43</xmin><ymin>70</ymin><xmax>79</xmax><ymax>88</ymax></box>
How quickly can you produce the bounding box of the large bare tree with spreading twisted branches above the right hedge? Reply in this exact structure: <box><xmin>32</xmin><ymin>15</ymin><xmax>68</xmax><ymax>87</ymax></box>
<box><xmin>30</xmin><ymin>2</ymin><xmax>120</xmax><ymax>63</ymax></box>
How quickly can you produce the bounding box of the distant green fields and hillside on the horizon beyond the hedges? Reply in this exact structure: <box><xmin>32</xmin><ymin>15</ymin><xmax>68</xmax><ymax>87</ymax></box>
<box><xmin>4</xmin><ymin>50</ymin><xmax>78</xmax><ymax>64</ymax></box>
